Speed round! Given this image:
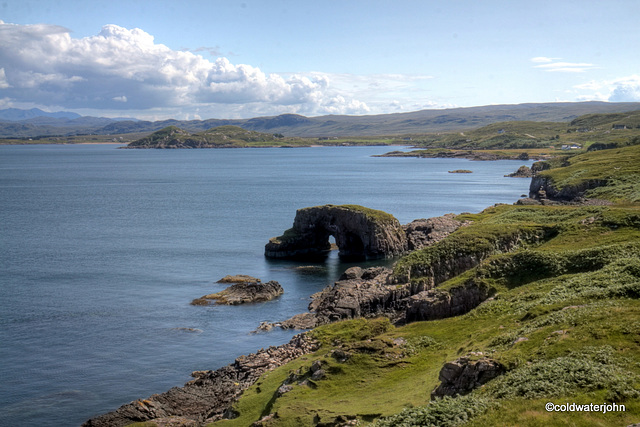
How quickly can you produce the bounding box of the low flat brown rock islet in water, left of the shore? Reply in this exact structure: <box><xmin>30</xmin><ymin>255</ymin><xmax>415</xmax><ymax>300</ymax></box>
<box><xmin>191</xmin><ymin>280</ymin><xmax>284</xmax><ymax>305</ymax></box>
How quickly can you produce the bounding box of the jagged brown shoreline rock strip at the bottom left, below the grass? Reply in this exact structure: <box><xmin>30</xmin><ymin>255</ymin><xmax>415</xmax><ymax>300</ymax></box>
<box><xmin>83</xmin><ymin>334</ymin><xmax>320</xmax><ymax>427</ymax></box>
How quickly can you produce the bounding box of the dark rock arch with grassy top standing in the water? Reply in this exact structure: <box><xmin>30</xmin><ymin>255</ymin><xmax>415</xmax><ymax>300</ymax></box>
<box><xmin>265</xmin><ymin>205</ymin><xmax>407</xmax><ymax>260</ymax></box>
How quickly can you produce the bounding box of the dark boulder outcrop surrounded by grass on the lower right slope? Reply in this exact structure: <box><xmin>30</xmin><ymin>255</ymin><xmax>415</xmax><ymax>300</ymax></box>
<box><xmin>431</xmin><ymin>357</ymin><xmax>506</xmax><ymax>399</ymax></box>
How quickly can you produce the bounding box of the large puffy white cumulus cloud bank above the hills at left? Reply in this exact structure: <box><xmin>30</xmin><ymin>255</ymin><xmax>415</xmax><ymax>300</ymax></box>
<box><xmin>0</xmin><ymin>21</ymin><xmax>368</xmax><ymax>114</ymax></box>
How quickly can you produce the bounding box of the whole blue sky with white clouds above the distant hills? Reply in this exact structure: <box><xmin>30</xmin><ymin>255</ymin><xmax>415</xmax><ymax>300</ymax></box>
<box><xmin>0</xmin><ymin>0</ymin><xmax>640</xmax><ymax>120</ymax></box>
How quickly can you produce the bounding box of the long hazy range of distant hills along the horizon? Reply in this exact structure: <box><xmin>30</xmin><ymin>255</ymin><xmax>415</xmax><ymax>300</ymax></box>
<box><xmin>0</xmin><ymin>102</ymin><xmax>640</xmax><ymax>138</ymax></box>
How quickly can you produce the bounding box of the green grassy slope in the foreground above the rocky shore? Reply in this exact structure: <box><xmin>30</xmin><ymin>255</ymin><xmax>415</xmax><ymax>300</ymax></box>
<box><xmin>206</xmin><ymin>143</ymin><xmax>640</xmax><ymax>426</ymax></box>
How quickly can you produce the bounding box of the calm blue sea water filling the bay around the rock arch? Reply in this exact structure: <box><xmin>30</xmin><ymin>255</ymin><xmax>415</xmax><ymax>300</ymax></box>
<box><xmin>0</xmin><ymin>145</ymin><xmax>529</xmax><ymax>426</ymax></box>
